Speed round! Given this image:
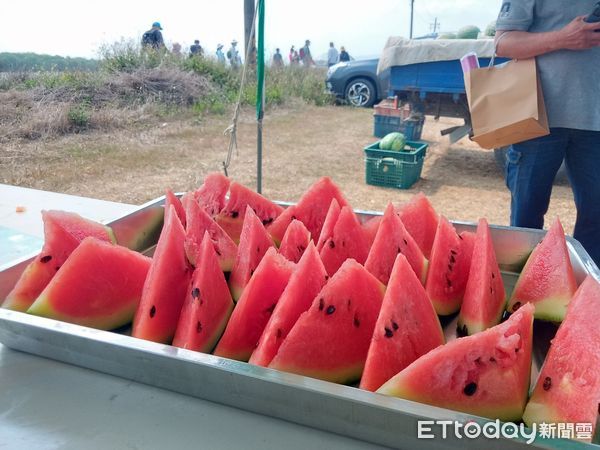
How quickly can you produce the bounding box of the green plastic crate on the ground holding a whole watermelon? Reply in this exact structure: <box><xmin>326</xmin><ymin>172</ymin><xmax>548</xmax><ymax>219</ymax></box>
<box><xmin>365</xmin><ymin>141</ymin><xmax>427</xmax><ymax>189</ymax></box>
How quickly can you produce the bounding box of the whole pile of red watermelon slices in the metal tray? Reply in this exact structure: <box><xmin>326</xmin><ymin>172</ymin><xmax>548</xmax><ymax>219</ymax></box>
<box><xmin>2</xmin><ymin>174</ymin><xmax>600</xmax><ymax>442</ymax></box>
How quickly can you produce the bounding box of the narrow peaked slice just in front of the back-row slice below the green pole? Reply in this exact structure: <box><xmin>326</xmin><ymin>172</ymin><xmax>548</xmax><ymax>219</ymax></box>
<box><xmin>229</xmin><ymin>206</ymin><xmax>273</xmax><ymax>301</ymax></box>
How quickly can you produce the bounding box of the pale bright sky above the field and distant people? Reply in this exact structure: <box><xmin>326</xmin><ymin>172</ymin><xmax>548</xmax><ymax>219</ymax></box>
<box><xmin>0</xmin><ymin>0</ymin><xmax>501</xmax><ymax>58</ymax></box>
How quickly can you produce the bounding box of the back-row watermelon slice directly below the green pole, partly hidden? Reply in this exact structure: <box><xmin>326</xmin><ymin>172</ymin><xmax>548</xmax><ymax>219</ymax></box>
<box><xmin>215</xmin><ymin>182</ymin><xmax>283</xmax><ymax>244</ymax></box>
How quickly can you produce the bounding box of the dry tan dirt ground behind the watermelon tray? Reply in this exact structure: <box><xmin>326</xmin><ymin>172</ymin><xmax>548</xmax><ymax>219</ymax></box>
<box><xmin>0</xmin><ymin>105</ymin><xmax>575</xmax><ymax>232</ymax></box>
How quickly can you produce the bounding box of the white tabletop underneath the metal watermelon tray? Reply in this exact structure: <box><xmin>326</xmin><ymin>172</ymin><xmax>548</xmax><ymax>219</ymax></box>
<box><xmin>0</xmin><ymin>185</ymin><xmax>381</xmax><ymax>450</ymax></box>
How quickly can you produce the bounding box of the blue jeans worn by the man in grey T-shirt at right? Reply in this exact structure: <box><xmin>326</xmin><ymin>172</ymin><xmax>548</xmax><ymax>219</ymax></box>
<box><xmin>506</xmin><ymin>128</ymin><xmax>600</xmax><ymax>266</ymax></box>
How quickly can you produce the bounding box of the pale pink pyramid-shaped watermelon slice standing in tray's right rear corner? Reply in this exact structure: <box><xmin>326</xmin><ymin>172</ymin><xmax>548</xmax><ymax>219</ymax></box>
<box><xmin>506</xmin><ymin>218</ymin><xmax>577</xmax><ymax>322</ymax></box>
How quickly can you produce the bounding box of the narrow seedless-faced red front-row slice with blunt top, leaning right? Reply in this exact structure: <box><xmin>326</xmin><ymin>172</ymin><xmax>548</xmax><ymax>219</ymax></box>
<box><xmin>214</xmin><ymin>248</ymin><xmax>295</xmax><ymax>361</ymax></box>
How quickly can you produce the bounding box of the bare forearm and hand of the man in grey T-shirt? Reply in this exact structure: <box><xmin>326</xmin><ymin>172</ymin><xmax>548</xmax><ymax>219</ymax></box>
<box><xmin>496</xmin><ymin>16</ymin><xmax>600</xmax><ymax>59</ymax></box>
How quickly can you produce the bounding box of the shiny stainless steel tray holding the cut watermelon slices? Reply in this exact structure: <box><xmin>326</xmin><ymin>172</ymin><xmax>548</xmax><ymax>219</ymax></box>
<box><xmin>0</xmin><ymin>197</ymin><xmax>600</xmax><ymax>449</ymax></box>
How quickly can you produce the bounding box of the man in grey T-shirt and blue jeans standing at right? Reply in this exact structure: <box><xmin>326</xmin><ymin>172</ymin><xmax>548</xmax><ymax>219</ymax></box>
<box><xmin>495</xmin><ymin>0</ymin><xmax>600</xmax><ymax>265</ymax></box>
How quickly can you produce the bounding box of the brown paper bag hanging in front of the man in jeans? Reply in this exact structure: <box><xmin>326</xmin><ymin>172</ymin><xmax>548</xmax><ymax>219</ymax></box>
<box><xmin>465</xmin><ymin>58</ymin><xmax>550</xmax><ymax>148</ymax></box>
